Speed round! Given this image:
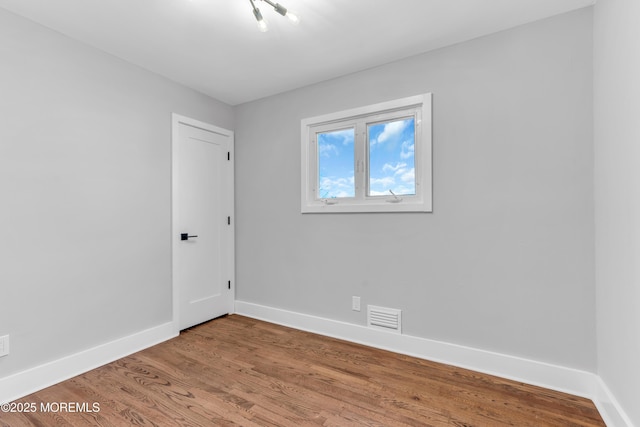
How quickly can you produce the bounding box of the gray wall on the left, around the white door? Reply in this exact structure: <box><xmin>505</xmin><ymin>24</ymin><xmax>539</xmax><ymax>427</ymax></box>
<box><xmin>0</xmin><ymin>9</ymin><xmax>234</xmax><ymax>377</ymax></box>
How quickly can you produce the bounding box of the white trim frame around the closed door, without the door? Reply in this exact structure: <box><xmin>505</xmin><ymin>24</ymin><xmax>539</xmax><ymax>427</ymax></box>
<box><xmin>171</xmin><ymin>113</ymin><xmax>236</xmax><ymax>333</ymax></box>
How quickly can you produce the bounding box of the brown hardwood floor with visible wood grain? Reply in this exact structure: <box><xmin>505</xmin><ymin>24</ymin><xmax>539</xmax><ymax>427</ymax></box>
<box><xmin>0</xmin><ymin>315</ymin><xmax>604</xmax><ymax>427</ymax></box>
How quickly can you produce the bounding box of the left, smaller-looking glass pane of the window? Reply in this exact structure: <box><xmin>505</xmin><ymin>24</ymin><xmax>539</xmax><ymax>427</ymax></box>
<box><xmin>316</xmin><ymin>128</ymin><xmax>356</xmax><ymax>199</ymax></box>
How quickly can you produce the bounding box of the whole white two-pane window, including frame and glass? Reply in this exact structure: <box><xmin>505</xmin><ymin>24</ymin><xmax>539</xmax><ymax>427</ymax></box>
<box><xmin>302</xmin><ymin>93</ymin><xmax>432</xmax><ymax>213</ymax></box>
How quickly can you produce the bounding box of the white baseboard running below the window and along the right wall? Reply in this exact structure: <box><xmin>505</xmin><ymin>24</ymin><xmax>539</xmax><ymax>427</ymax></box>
<box><xmin>235</xmin><ymin>301</ymin><xmax>633</xmax><ymax>427</ymax></box>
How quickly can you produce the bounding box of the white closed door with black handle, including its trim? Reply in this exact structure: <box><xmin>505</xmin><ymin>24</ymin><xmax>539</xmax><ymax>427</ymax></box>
<box><xmin>172</xmin><ymin>114</ymin><xmax>234</xmax><ymax>330</ymax></box>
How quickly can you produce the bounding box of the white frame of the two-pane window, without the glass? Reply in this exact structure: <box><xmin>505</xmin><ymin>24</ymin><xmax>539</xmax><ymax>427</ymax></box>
<box><xmin>301</xmin><ymin>93</ymin><xmax>432</xmax><ymax>214</ymax></box>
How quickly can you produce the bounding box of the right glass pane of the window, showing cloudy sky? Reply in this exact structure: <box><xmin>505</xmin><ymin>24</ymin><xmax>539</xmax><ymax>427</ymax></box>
<box><xmin>367</xmin><ymin>117</ymin><xmax>416</xmax><ymax>196</ymax></box>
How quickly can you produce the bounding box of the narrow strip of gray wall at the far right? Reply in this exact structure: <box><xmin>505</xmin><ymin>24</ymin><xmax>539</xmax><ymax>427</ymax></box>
<box><xmin>594</xmin><ymin>0</ymin><xmax>640</xmax><ymax>426</ymax></box>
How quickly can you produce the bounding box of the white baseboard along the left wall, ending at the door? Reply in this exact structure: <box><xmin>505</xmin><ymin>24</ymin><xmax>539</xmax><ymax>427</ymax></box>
<box><xmin>0</xmin><ymin>322</ymin><xmax>178</xmax><ymax>403</ymax></box>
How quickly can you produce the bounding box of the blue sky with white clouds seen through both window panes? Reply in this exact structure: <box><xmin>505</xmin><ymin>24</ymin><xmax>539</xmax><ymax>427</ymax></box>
<box><xmin>318</xmin><ymin>117</ymin><xmax>415</xmax><ymax>198</ymax></box>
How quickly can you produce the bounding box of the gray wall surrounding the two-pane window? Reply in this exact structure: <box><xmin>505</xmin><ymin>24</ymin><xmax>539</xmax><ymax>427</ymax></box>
<box><xmin>236</xmin><ymin>9</ymin><xmax>596</xmax><ymax>371</ymax></box>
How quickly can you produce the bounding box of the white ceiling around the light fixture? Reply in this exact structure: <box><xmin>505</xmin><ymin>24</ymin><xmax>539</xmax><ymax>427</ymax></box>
<box><xmin>0</xmin><ymin>0</ymin><xmax>595</xmax><ymax>105</ymax></box>
